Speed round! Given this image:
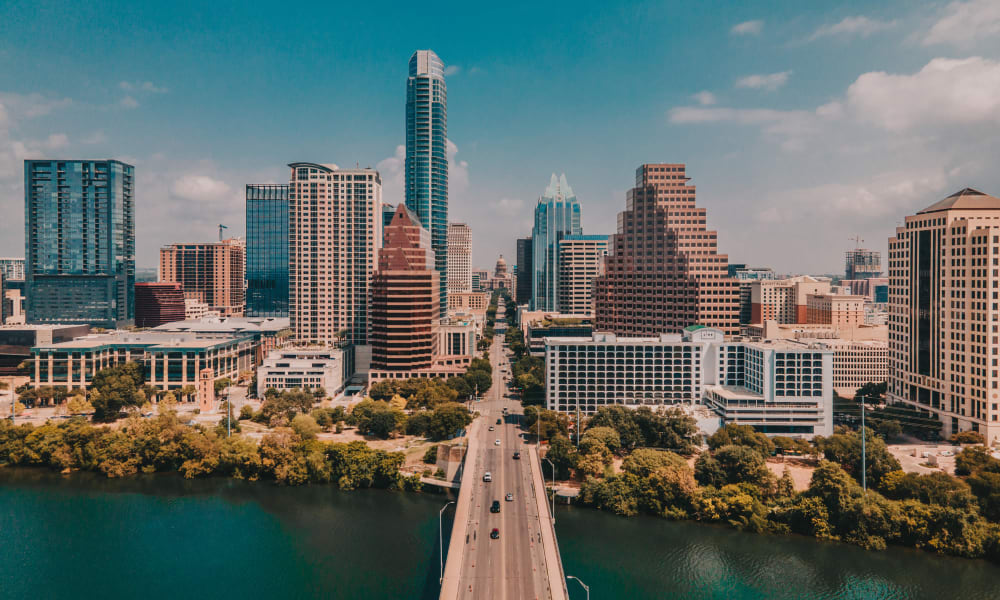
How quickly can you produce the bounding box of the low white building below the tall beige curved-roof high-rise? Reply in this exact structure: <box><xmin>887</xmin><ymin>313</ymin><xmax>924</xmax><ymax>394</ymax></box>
<box><xmin>257</xmin><ymin>348</ymin><xmax>353</xmax><ymax>397</ymax></box>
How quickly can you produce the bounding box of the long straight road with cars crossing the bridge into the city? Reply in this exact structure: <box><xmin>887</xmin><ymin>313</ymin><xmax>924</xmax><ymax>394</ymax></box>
<box><xmin>449</xmin><ymin>302</ymin><xmax>561</xmax><ymax>599</ymax></box>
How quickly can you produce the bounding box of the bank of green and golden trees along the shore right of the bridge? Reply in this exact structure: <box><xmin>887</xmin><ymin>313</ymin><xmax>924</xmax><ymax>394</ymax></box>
<box><xmin>525</xmin><ymin>406</ymin><xmax>1000</xmax><ymax>563</ymax></box>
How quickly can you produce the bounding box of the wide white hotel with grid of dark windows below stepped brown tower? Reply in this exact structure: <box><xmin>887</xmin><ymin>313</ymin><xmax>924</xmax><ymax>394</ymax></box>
<box><xmin>545</xmin><ymin>326</ymin><xmax>833</xmax><ymax>438</ymax></box>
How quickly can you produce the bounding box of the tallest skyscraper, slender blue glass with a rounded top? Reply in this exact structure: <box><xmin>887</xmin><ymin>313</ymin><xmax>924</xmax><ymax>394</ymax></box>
<box><xmin>404</xmin><ymin>50</ymin><xmax>448</xmax><ymax>316</ymax></box>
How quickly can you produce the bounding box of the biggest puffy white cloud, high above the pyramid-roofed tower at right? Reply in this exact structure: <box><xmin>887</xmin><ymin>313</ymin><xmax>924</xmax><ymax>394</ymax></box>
<box><xmin>847</xmin><ymin>56</ymin><xmax>1000</xmax><ymax>131</ymax></box>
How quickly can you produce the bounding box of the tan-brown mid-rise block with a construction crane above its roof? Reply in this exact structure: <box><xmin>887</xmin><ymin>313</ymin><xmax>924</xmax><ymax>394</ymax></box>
<box><xmin>160</xmin><ymin>238</ymin><xmax>246</xmax><ymax>317</ymax></box>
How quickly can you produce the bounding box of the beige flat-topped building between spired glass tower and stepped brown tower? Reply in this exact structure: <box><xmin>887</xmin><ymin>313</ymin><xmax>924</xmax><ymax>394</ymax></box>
<box><xmin>557</xmin><ymin>235</ymin><xmax>608</xmax><ymax>315</ymax></box>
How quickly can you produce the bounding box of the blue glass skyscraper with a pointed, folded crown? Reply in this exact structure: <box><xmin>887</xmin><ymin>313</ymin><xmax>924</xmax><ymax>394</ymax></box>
<box><xmin>531</xmin><ymin>173</ymin><xmax>583</xmax><ymax>310</ymax></box>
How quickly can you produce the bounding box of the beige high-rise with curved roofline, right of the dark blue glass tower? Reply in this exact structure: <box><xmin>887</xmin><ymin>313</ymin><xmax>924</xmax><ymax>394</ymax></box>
<box><xmin>288</xmin><ymin>163</ymin><xmax>382</xmax><ymax>345</ymax></box>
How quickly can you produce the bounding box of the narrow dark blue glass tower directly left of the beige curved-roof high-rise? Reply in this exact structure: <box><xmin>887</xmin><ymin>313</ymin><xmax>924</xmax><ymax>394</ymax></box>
<box><xmin>246</xmin><ymin>183</ymin><xmax>288</xmax><ymax>317</ymax></box>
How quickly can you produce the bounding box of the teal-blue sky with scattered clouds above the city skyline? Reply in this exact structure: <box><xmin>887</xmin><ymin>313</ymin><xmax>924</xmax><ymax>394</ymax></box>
<box><xmin>0</xmin><ymin>0</ymin><xmax>1000</xmax><ymax>274</ymax></box>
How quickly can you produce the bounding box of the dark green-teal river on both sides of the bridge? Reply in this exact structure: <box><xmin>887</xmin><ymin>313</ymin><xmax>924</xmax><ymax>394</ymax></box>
<box><xmin>0</xmin><ymin>469</ymin><xmax>1000</xmax><ymax>600</ymax></box>
